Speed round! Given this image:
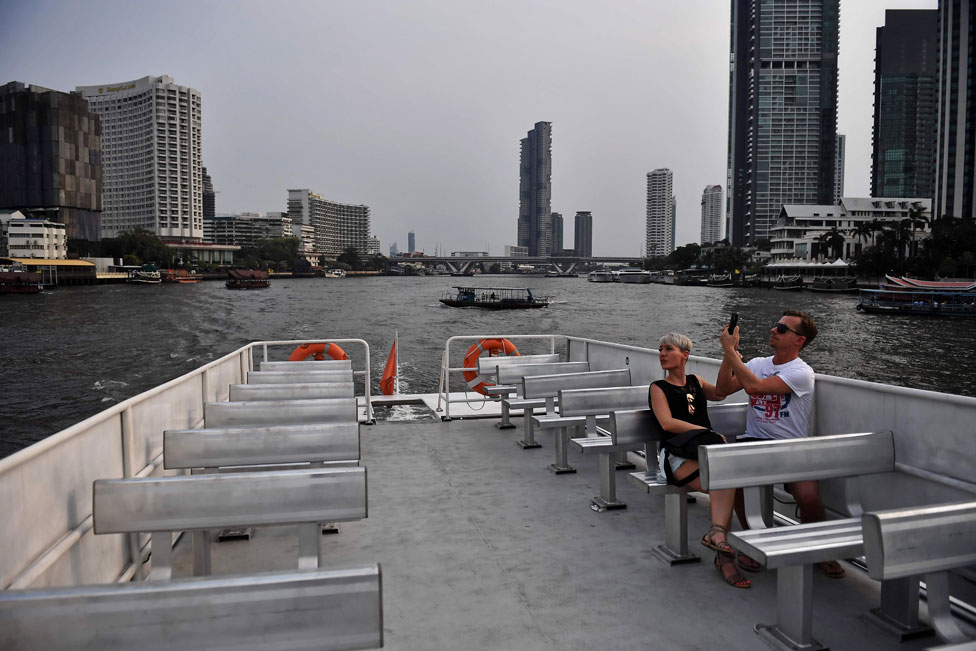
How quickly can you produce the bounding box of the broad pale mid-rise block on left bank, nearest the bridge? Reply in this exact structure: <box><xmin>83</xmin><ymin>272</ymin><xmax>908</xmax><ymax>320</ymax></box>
<box><xmin>288</xmin><ymin>188</ymin><xmax>369</xmax><ymax>256</ymax></box>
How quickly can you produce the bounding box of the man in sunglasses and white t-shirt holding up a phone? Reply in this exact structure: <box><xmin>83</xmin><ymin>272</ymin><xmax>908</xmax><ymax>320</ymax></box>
<box><xmin>715</xmin><ymin>310</ymin><xmax>846</xmax><ymax>579</ymax></box>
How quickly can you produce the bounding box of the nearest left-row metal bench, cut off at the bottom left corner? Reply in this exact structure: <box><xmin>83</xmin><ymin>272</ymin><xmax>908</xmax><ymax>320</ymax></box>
<box><xmin>0</xmin><ymin>565</ymin><xmax>383</xmax><ymax>651</ymax></box>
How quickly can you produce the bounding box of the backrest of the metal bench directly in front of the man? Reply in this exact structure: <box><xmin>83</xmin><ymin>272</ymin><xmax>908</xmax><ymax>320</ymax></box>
<box><xmin>698</xmin><ymin>431</ymin><xmax>895</xmax><ymax>490</ymax></box>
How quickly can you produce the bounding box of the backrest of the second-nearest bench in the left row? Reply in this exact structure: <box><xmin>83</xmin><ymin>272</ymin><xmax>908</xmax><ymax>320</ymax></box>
<box><xmin>92</xmin><ymin>467</ymin><xmax>366</xmax><ymax>534</ymax></box>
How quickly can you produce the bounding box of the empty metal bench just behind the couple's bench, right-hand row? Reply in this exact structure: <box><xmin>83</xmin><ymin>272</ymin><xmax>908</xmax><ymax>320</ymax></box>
<box><xmin>532</xmin><ymin>384</ymin><xmax>648</xmax><ymax>475</ymax></box>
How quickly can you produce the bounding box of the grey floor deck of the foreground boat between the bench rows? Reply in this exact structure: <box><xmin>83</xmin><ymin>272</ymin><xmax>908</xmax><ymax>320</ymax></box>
<box><xmin>175</xmin><ymin>413</ymin><xmax>960</xmax><ymax>651</ymax></box>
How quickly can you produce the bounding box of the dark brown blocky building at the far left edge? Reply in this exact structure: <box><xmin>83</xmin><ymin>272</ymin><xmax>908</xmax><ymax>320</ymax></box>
<box><xmin>0</xmin><ymin>81</ymin><xmax>102</xmax><ymax>241</ymax></box>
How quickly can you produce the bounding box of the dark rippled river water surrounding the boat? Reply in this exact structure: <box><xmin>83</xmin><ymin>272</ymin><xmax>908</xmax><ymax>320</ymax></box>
<box><xmin>0</xmin><ymin>276</ymin><xmax>976</xmax><ymax>457</ymax></box>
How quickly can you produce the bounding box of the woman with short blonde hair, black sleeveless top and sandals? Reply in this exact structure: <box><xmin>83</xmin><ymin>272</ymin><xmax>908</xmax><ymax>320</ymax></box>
<box><xmin>649</xmin><ymin>332</ymin><xmax>752</xmax><ymax>588</ymax></box>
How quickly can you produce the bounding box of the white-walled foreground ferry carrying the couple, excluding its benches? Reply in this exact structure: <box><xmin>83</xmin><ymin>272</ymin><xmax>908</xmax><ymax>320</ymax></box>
<box><xmin>0</xmin><ymin>334</ymin><xmax>976</xmax><ymax>651</ymax></box>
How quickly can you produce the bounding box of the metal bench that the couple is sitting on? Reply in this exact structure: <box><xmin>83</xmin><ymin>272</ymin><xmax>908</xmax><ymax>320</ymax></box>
<box><xmin>620</xmin><ymin>402</ymin><xmax>749</xmax><ymax>565</ymax></box>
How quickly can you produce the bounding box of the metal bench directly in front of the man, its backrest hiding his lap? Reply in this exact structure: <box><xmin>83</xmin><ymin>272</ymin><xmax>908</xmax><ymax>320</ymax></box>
<box><xmin>698</xmin><ymin>431</ymin><xmax>912</xmax><ymax>649</ymax></box>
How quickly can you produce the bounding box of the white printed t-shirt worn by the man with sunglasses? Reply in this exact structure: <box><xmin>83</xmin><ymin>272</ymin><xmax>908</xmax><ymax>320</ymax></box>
<box><xmin>746</xmin><ymin>357</ymin><xmax>813</xmax><ymax>439</ymax></box>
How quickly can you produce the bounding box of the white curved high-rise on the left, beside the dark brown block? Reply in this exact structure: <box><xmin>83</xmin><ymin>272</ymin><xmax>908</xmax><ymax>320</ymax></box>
<box><xmin>76</xmin><ymin>75</ymin><xmax>203</xmax><ymax>241</ymax></box>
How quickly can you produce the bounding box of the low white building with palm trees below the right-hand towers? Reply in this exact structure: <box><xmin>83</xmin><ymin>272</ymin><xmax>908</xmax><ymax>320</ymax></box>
<box><xmin>770</xmin><ymin>197</ymin><xmax>932</xmax><ymax>262</ymax></box>
